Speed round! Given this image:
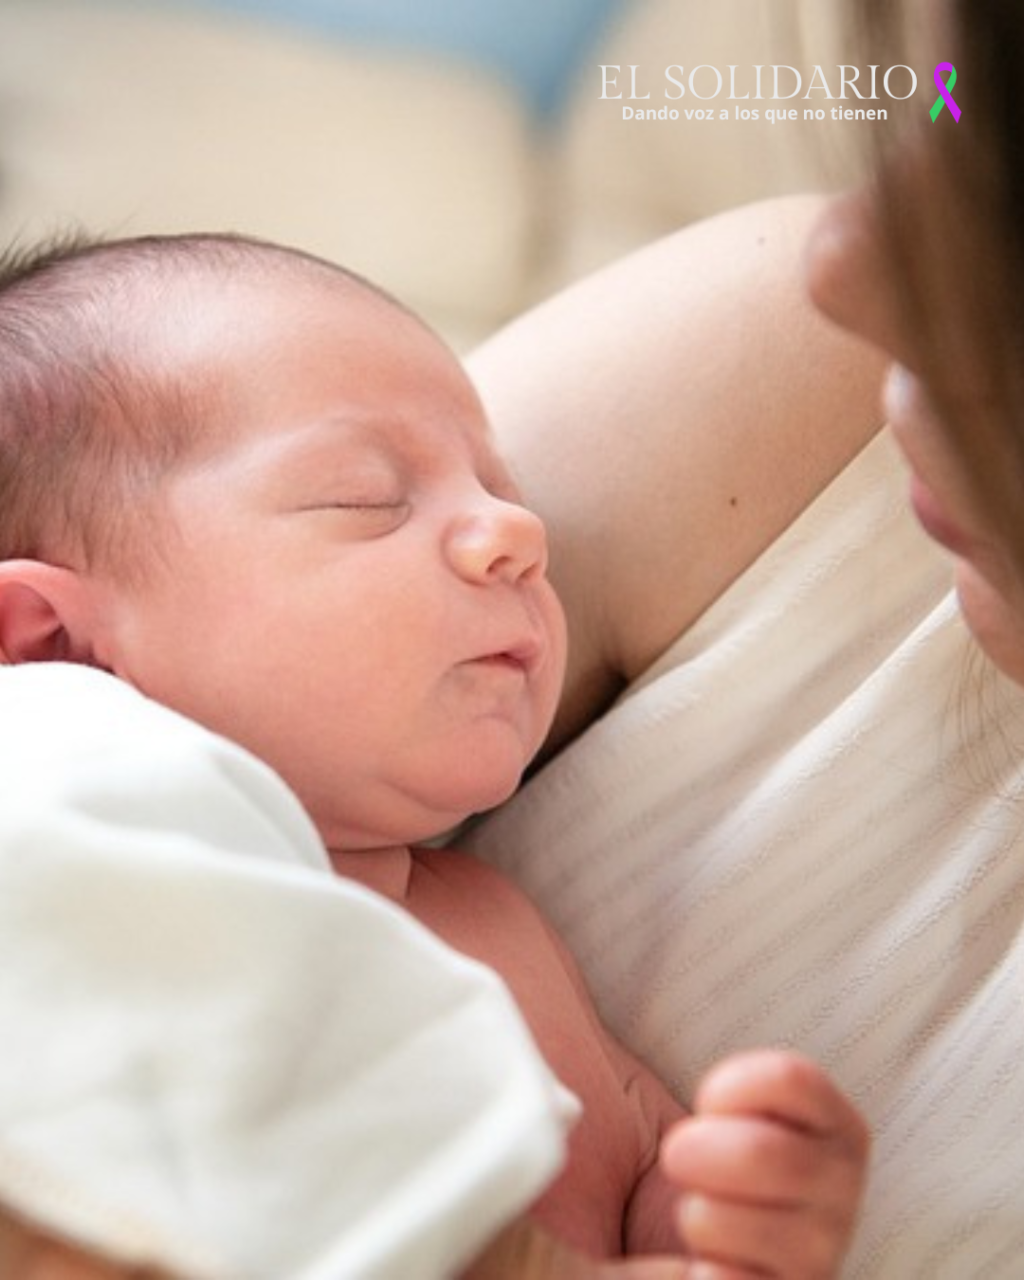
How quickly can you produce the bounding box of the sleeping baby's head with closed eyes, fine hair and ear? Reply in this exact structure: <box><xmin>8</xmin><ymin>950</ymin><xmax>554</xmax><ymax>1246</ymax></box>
<box><xmin>0</xmin><ymin>237</ymin><xmax>564</xmax><ymax>849</ymax></box>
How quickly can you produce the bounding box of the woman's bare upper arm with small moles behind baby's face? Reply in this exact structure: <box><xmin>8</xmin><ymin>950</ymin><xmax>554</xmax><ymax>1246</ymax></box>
<box><xmin>468</xmin><ymin>196</ymin><xmax>883</xmax><ymax>754</ymax></box>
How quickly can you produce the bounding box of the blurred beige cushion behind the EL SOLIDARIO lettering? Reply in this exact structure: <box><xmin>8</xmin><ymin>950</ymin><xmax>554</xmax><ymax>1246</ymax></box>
<box><xmin>549</xmin><ymin>0</ymin><xmax>863</xmax><ymax>288</ymax></box>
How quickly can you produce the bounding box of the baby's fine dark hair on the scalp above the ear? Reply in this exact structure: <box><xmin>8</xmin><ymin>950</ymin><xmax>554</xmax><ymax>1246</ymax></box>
<box><xmin>0</xmin><ymin>234</ymin><xmax>398</xmax><ymax>572</ymax></box>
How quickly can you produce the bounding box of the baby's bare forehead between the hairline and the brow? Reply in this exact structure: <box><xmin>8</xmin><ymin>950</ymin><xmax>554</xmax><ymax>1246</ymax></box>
<box><xmin>135</xmin><ymin>257</ymin><xmax>494</xmax><ymax>453</ymax></box>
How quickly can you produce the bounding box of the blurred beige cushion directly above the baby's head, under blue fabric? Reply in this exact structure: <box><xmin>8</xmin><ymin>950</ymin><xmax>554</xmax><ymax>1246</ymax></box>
<box><xmin>0</xmin><ymin>0</ymin><xmax>539</xmax><ymax>340</ymax></box>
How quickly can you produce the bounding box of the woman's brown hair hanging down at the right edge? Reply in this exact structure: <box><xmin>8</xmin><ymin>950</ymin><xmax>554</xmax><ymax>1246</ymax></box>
<box><xmin>847</xmin><ymin>0</ymin><xmax>1024</xmax><ymax>582</ymax></box>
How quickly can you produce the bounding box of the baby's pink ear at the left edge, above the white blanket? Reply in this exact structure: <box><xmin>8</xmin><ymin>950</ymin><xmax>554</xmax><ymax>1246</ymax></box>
<box><xmin>0</xmin><ymin>559</ymin><xmax>92</xmax><ymax>664</ymax></box>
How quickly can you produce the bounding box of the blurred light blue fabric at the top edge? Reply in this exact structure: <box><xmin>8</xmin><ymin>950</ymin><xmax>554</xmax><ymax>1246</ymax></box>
<box><xmin>164</xmin><ymin>0</ymin><xmax>623</xmax><ymax>114</ymax></box>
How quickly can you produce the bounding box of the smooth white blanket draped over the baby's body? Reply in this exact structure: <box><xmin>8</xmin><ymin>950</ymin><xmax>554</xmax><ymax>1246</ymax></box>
<box><xmin>0</xmin><ymin>666</ymin><xmax>562</xmax><ymax>1280</ymax></box>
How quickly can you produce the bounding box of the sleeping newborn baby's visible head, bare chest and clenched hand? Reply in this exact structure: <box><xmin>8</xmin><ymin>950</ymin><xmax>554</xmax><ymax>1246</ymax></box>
<box><xmin>0</xmin><ymin>227</ymin><xmax>867</xmax><ymax>1276</ymax></box>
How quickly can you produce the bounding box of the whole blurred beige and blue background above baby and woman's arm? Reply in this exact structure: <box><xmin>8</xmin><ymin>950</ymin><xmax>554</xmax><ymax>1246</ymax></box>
<box><xmin>0</xmin><ymin>0</ymin><xmax>865</xmax><ymax>349</ymax></box>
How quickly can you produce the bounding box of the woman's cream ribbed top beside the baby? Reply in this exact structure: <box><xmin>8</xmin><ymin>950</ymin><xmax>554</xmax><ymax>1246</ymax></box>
<box><xmin>467</xmin><ymin>438</ymin><xmax>1024</xmax><ymax>1280</ymax></box>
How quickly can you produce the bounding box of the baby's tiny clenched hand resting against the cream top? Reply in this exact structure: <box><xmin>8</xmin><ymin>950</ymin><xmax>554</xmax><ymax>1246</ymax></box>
<box><xmin>660</xmin><ymin>1051</ymin><xmax>869</xmax><ymax>1280</ymax></box>
